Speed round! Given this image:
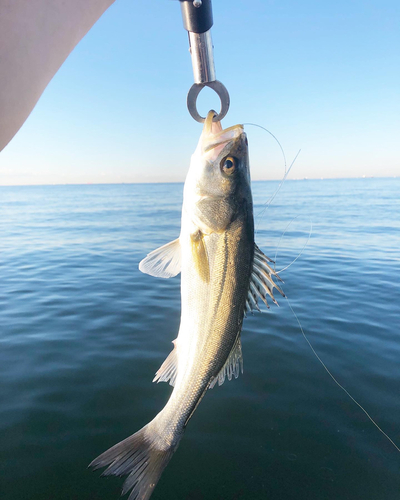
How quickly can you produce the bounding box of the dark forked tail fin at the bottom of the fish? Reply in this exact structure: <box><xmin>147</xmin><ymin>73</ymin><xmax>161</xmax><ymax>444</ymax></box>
<box><xmin>89</xmin><ymin>422</ymin><xmax>179</xmax><ymax>500</ymax></box>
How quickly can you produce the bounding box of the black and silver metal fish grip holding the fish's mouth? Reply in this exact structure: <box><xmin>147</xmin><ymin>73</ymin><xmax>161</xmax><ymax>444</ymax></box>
<box><xmin>179</xmin><ymin>0</ymin><xmax>230</xmax><ymax>123</ymax></box>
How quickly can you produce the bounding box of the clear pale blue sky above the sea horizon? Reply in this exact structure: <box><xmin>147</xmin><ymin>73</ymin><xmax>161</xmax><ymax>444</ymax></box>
<box><xmin>0</xmin><ymin>0</ymin><xmax>400</xmax><ymax>185</ymax></box>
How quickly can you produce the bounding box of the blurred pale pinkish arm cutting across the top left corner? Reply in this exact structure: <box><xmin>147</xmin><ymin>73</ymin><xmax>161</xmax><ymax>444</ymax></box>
<box><xmin>0</xmin><ymin>0</ymin><xmax>114</xmax><ymax>151</ymax></box>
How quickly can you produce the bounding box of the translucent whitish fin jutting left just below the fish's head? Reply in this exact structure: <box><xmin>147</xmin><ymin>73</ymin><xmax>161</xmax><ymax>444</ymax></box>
<box><xmin>139</xmin><ymin>238</ymin><xmax>181</xmax><ymax>278</ymax></box>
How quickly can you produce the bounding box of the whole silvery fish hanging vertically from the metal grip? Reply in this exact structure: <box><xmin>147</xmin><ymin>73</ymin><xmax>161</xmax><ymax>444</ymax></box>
<box><xmin>90</xmin><ymin>110</ymin><xmax>284</xmax><ymax>500</ymax></box>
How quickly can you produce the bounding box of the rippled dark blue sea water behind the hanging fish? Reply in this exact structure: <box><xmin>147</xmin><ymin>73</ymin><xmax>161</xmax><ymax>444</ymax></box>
<box><xmin>0</xmin><ymin>179</ymin><xmax>400</xmax><ymax>500</ymax></box>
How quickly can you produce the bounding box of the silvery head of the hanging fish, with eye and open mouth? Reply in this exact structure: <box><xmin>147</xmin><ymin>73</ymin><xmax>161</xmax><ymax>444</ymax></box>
<box><xmin>184</xmin><ymin>111</ymin><xmax>252</xmax><ymax>234</ymax></box>
